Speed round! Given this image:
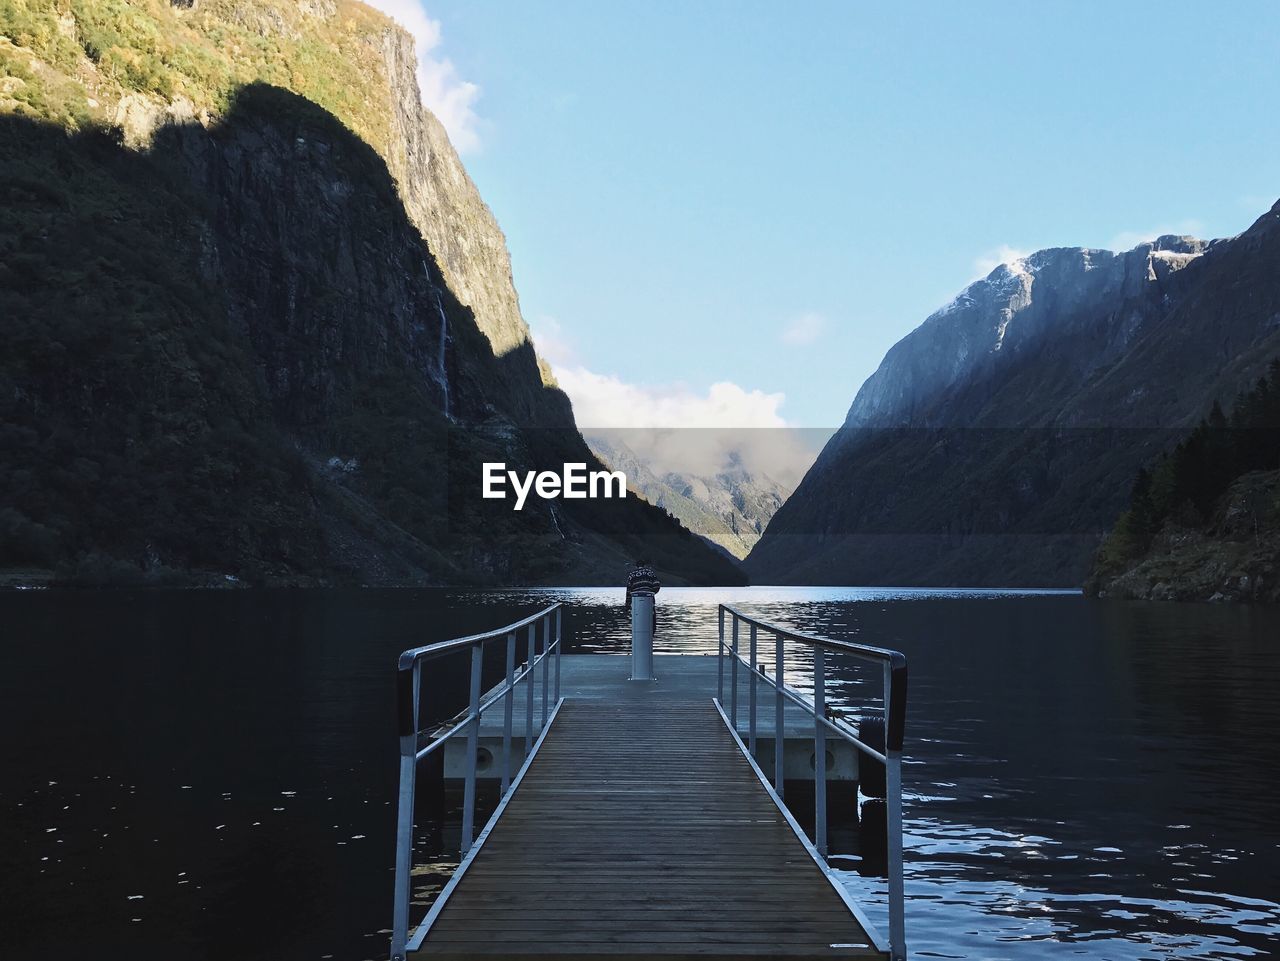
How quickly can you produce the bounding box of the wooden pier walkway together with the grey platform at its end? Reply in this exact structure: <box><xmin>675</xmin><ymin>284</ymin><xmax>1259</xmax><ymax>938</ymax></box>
<box><xmin>393</xmin><ymin>603</ymin><xmax>905</xmax><ymax>961</ymax></box>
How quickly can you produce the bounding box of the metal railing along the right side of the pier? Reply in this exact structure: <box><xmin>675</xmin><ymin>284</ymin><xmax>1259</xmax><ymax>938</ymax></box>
<box><xmin>716</xmin><ymin>604</ymin><xmax>906</xmax><ymax>961</ymax></box>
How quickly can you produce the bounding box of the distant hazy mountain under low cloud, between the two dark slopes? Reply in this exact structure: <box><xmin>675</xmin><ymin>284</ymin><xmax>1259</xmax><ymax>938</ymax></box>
<box><xmin>584</xmin><ymin>430</ymin><xmax>791</xmax><ymax>560</ymax></box>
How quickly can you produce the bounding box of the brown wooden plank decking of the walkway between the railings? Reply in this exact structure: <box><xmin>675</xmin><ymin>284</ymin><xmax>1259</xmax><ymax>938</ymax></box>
<box><xmin>412</xmin><ymin>658</ymin><xmax>884</xmax><ymax>961</ymax></box>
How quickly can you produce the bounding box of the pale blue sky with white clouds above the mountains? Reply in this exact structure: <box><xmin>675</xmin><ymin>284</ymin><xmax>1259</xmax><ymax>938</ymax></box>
<box><xmin>379</xmin><ymin>0</ymin><xmax>1280</xmax><ymax>426</ymax></box>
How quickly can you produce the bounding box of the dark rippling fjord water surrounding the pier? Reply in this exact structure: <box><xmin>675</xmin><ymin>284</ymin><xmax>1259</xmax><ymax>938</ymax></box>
<box><xmin>0</xmin><ymin>587</ymin><xmax>1280</xmax><ymax>961</ymax></box>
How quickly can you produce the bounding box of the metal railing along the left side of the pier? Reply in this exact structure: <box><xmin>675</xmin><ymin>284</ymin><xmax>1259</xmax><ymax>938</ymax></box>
<box><xmin>392</xmin><ymin>604</ymin><xmax>561</xmax><ymax>961</ymax></box>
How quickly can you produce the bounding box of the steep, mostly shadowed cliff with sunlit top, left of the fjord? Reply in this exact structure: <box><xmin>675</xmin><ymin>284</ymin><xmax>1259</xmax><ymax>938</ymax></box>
<box><xmin>0</xmin><ymin>0</ymin><xmax>740</xmax><ymax>584</ymax></box>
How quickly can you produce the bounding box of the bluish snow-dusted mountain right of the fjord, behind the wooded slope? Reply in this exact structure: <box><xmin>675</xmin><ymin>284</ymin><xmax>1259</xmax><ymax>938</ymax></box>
<box><xmin>746</xmin><ymin>206</ymin><xmax>1280</xmax><ymax>586</ymax></box>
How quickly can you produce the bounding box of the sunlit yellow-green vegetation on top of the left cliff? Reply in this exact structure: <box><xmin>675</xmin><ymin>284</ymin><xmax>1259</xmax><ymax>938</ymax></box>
<box><xmin>0</xmin><ymin>0</ymin><xmax>390</xmax><ymax>150</ymax></box>
